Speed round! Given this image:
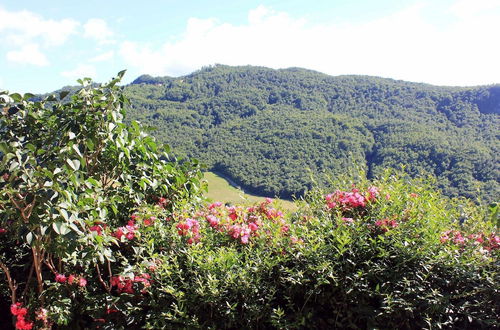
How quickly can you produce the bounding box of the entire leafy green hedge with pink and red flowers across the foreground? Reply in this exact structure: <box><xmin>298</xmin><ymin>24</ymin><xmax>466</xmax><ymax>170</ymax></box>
<box><xmin>0</xmin><ymin>77</ymin><xmax>500</xmax><ymax>329</ymax></box>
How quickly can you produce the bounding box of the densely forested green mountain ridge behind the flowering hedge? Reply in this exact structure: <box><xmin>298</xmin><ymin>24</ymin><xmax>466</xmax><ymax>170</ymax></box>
<box><xmin>125</xmin><ymin>65</ymin><xmax>500</xmax><ymax>200</ymax></box>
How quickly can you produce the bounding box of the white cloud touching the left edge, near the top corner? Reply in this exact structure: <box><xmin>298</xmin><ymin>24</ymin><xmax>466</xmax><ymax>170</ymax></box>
<box><xmin>0</xmin><ymin>8</ymin><xmax>79</xmax><ymax>46</ymax></box>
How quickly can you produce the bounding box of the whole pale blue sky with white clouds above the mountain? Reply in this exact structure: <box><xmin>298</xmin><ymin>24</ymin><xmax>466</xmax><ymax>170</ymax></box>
<box><xmin>0</xmin><ymin>0</ymin><xmax>500</xmax><ymax>93</ymax></box>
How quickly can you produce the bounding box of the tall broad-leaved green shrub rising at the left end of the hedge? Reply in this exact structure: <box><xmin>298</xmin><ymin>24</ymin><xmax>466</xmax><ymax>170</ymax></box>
<box><xmin>0</xmin><ymin>72</ymin><xmax>201</xmax><ymax>324</ymax></box>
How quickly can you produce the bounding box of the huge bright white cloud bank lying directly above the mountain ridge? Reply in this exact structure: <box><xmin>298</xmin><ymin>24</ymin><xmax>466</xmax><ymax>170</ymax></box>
<box><xmin>120</xmin><ymin>0</ymin><xmax>500</xmax><ymax>85</ymax></box>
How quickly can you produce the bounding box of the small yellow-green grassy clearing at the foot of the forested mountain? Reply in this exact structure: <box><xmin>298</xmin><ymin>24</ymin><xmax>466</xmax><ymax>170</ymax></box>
<box><xmin>204</xmin><ymin>172</ymin><xmax>296</xmax><ymax>211</ymax></box>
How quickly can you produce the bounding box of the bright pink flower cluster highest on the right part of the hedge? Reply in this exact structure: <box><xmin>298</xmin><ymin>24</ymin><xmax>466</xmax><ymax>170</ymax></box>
<box><xmin>325</xmin><ymin>187</ymin><xmax>380</xmax><ymax>211</ymax></box>
